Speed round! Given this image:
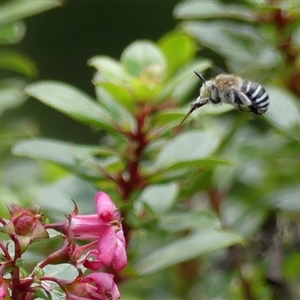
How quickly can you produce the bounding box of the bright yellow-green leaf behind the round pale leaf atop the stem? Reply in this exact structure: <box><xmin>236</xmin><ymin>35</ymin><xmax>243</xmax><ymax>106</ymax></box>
<box><xmin>158</xmin><ymin>31</ymin><xmax>197</xmax><ymax>76</ymax></box>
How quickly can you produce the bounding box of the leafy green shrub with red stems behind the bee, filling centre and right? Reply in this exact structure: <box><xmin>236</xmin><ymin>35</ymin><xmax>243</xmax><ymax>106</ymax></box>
<box><xmin>3</xmin><ymin>1</ymin><xmax>300</xmax><ymax>299</ymax></box>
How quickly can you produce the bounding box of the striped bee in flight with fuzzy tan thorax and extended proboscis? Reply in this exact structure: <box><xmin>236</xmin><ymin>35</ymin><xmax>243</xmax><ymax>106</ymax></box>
<box><xmin>179</xmin><ymin>71</ymin><xmax>270</xmax><ymax>126</ymax></box>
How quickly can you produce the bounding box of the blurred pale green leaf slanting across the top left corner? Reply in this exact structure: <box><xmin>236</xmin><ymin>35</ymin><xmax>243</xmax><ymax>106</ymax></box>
<box><xmin>0</xmin><ymin>0</ymin><xmax>62</xmax><ymax>25</ymax></box>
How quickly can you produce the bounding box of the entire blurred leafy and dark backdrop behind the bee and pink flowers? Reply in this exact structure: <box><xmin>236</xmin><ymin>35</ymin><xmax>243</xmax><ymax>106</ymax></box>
<box><xmin>0</xmin><ymin>0</ymin><xmax>300</xmax><ymax>300</ymax></box>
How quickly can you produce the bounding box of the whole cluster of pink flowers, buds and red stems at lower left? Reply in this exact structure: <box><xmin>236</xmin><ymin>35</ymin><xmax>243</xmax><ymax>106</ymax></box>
<box><xmin>0</xmin><ymin>192</ymin><xmax>127</xmax><ymax>300</ymax></box>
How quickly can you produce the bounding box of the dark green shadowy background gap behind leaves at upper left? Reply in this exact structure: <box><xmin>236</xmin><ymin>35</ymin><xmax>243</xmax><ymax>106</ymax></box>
<box><xmin>18</xmin><ymin>0</ymin><xmax>178</xmax><ymax>143</ymax></box>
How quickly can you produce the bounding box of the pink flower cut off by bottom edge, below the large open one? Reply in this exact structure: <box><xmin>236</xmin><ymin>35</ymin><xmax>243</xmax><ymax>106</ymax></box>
<box><xmin>67</xmin><ymin>273</ymin><xmax>120</xmax><ymax>300</ymax></box>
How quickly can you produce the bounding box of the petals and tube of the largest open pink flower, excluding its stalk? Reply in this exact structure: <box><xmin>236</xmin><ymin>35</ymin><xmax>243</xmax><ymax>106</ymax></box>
<box><xmin>68</xmin><ymin>192</ymin><xmax>127</xmax><ymax>271</ymax></box>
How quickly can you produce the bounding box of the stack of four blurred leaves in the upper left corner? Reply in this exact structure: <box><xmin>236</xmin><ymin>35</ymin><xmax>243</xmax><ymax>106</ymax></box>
<box><xmin>0</xmin><ymin>0</ymin><xmax>59</xmax><ymax>119</ymax></box>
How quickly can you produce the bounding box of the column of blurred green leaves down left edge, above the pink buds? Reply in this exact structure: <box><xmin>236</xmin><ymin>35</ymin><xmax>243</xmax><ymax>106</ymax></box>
<box><xmin>0</xmin><ymin>0</ymin><xmax>60</xmax><ymax>217</ymax></box>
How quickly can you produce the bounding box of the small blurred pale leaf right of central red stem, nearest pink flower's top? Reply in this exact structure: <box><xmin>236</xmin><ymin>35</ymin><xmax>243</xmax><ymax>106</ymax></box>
<box><xmin>139</xmin><ymin>182</ymin><xmax>178</xmax><ymax>213</ymax></box>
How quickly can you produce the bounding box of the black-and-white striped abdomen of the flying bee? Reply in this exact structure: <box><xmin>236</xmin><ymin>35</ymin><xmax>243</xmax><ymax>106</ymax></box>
<box><xmin>241</xmin><ymin>80</ymin><xmax>270</xmax><ymax>115</ymax></box>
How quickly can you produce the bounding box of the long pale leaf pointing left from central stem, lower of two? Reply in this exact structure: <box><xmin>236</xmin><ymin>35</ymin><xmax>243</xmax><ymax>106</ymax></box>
<box><xmin>12</xmin><ymin>139</ymin><xmax>101</xmax><ymax>178</ymax></box>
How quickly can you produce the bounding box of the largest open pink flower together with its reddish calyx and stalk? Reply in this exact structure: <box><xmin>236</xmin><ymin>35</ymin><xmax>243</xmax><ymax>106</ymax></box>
<box><xmin>47</xmin><ymin>192</ymin><xmax>127</xmax><ymax>271</ymax></box>
